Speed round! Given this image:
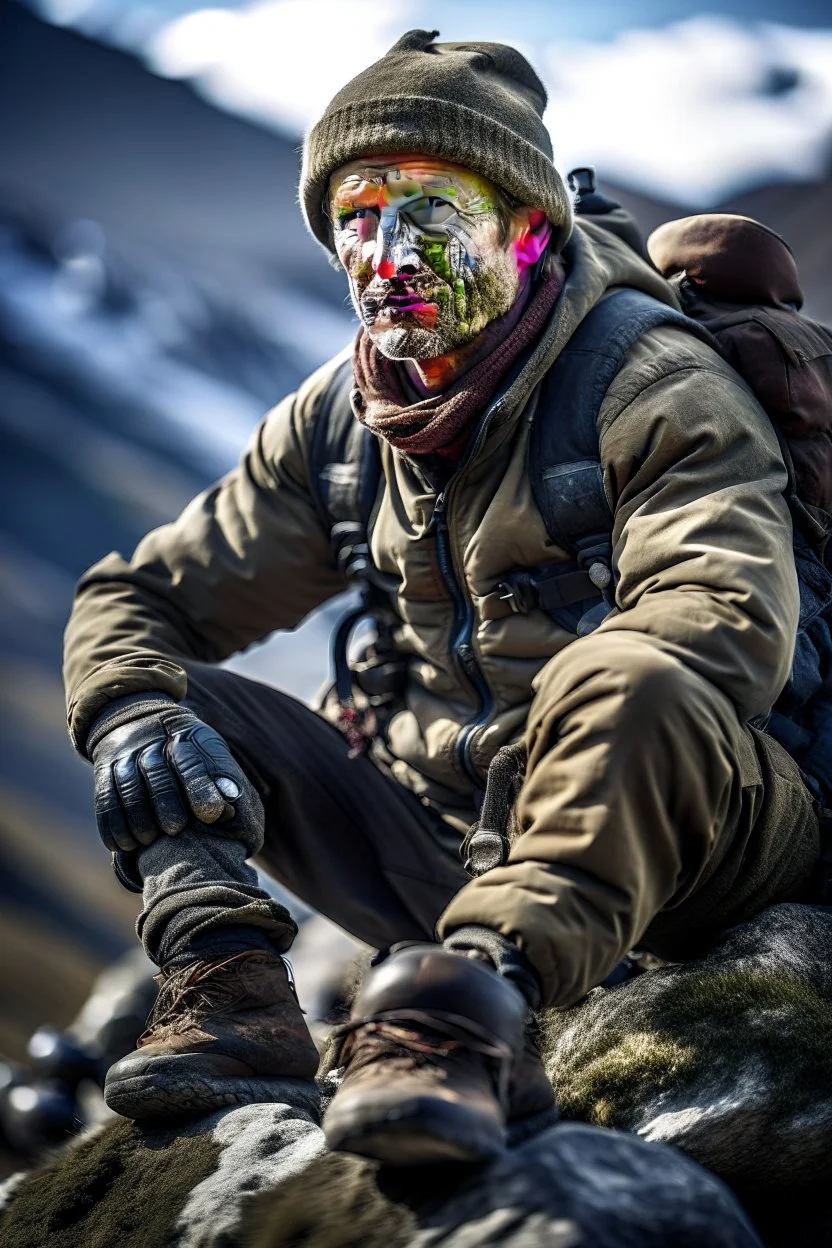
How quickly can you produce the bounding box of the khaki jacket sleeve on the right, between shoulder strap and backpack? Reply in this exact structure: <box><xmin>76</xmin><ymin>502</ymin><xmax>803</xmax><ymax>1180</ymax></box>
<box><xmin>599</xmin><ymin>329</ymin><xmax>800</xmax><ymax>720</ymax></box>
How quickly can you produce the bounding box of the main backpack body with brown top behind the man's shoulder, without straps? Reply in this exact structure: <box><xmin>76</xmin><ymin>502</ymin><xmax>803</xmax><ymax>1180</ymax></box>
<box><xmin>647</xmin><ymin>212</ymin><xmax>832</xmax><ymax>807</ymax></box>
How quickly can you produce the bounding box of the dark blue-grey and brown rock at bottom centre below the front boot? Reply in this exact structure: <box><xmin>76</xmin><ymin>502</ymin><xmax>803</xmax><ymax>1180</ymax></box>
<box><xmin>245</xmin><ymin>1123</ymin><xmax>760</xmax><ymax>1248</ymax></box>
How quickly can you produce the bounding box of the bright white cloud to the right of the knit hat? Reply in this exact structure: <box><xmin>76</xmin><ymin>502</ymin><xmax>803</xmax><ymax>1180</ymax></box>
<box><xmin>540</xmin><ymin>17</ymin><xmax>832</xmax><ymax>205</ymax></box>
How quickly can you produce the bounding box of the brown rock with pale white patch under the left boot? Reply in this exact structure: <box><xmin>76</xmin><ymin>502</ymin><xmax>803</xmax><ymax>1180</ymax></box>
<box><xmin>0</xmin><ymin>1080</ymin><xmax>324</xmax><ymax>1248</ymax></box>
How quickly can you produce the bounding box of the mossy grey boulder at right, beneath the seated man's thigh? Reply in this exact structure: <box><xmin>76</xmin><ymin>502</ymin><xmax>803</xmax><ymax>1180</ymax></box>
<box><xmin>541</xmin><ymin>905</ymin><xmax>832</xmax><ymax>1244</ymax></box>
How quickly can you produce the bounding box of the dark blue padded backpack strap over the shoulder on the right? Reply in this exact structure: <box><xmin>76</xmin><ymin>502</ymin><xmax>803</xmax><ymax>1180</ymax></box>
<box><xmin>503</xmin><ymin>287</ymin><xmax>710</xmax><ymax>635</ymax></box>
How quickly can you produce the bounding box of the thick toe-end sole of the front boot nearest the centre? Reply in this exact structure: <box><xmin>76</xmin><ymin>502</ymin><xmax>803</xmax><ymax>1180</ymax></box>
<box><xmin>323</xmin><ymin>1097</ymin><xmax>505</xmax><ymax>1166</ymax></box>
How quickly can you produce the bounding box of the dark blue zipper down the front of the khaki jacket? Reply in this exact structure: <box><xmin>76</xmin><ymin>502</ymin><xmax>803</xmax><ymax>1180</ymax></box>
<box><xmin>433</xmin><ymin>401</ymin><xmax>500</xmax><ymax>790</ymax></box>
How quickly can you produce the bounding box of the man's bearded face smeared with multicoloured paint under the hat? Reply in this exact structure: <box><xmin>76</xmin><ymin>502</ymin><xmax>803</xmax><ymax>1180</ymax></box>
<box><xmin>329</xmin><ymin>156</ymin><xmax>550</xmax><ymax>359</ymax></box>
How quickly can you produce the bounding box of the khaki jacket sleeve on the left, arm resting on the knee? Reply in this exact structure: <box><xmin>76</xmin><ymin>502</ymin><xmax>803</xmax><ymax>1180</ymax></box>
<box><xmin>64</xmin><ymin>374</ymin><xmax>344</xmax><ymax>751</ymax></box>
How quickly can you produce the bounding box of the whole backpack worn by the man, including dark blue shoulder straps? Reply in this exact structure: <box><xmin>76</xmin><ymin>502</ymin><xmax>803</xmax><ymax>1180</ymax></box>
<box><xmin>309</xmin><ymin>170</ymin><xmax>832</xmax><ymax>838</ymax></box>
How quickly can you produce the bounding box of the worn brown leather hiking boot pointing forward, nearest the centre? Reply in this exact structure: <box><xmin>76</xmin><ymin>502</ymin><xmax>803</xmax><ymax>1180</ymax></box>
<box><xmin>323</xmin><ymin>945</ymin><xmax>554</xmax><ymax>1166</ymax></box>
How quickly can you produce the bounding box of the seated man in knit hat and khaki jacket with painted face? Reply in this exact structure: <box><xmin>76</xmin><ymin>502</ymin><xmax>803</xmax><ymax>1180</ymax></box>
<box><xmin>66</xmin><ymin>31</ymin><xmax>818</xmax><ymax>1164</ymax></box>
